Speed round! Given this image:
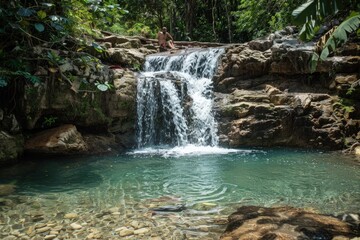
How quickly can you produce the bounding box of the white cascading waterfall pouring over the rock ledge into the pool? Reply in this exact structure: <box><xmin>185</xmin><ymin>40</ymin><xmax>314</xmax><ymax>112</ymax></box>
<box><xmin>137</xmin><ymin>48</ymin><xmax>224</xmax><ymax>148</ymax></box>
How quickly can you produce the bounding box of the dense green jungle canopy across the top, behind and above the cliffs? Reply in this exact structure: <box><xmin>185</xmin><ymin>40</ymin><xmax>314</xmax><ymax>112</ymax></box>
<box><xmin>0</xmin><ymin>0</ymin><xmax>360</xmax><ymax>93</ymax></box>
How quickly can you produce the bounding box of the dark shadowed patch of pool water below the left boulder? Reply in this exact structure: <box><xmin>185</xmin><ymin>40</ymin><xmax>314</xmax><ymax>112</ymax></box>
<box><xmin>0</xmin><ymin>157</ymin><xmax>103</xmax><ymax>193</ymax></box>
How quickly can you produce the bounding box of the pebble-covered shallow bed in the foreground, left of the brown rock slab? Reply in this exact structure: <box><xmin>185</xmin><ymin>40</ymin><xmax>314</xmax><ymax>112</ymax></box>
<box><xmin>0</xmin><ymin>189</ymin><xmax>227</xmax><ymax>240</ymax></box>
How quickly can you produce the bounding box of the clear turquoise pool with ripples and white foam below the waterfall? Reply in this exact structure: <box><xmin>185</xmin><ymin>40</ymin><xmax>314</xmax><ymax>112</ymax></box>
<box><xmin>0</xmin><ymin>146</ymin><xmax>360</xmax><ymax>214</ymax></box>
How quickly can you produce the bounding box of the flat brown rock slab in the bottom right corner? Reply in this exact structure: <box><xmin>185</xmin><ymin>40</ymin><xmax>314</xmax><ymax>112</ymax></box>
<box><xmin>220</xmin><ymin>206</ymin><xmax>360</xmax><ymax>240</ymax></box>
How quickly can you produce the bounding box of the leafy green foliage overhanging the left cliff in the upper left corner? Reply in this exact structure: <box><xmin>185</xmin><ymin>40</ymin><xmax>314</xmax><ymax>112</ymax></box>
<box><xmin>0</xmin><ymin>0</ymin><xmax>126</xmax><ymax>94</ymax></box>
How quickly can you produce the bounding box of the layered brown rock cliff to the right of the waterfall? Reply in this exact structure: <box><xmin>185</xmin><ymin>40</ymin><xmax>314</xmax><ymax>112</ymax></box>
<box><xmin>215</xmin><ymin>30</ymin><xmax>360</xmax><ymax>150</ymax></box>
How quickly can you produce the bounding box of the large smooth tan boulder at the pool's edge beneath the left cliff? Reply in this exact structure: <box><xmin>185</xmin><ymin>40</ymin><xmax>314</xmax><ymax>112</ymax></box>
<box><xmin>25</xmin><ymin>124</ymin><xmax>88</xmax><ymax>155</ymax></box>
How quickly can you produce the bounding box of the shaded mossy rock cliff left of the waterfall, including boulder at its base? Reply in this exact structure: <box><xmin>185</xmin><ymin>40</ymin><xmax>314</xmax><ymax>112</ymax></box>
<box><xmin>0</xmin><ymin>36</ymin><xmax>156</xmax><ymax>165</ymax></box>
